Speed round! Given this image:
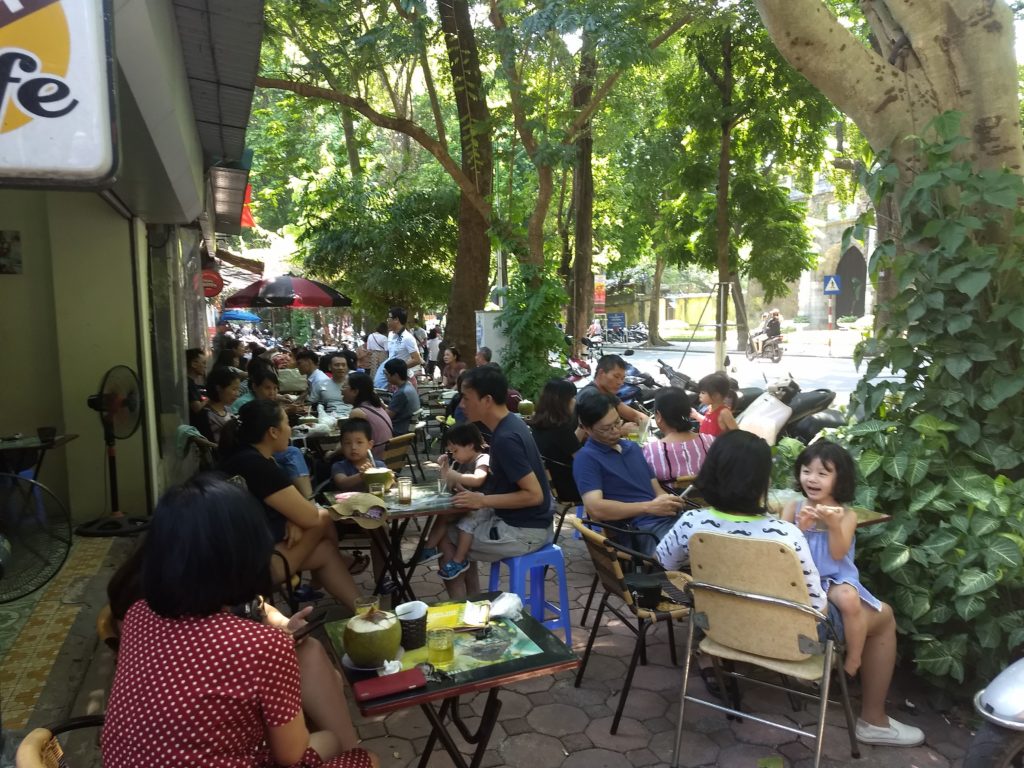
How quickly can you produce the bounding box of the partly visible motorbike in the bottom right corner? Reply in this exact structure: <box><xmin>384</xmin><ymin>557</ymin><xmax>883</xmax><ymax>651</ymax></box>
<box><xmin>964</xmin><ymin>658</ymin><xmax>1024</xmax><ymax>768</ymax></box>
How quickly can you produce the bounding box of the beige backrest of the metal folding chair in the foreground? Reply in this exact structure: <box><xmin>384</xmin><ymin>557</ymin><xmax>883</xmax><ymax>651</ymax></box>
<box><xmin>689</xmin><ymin>531</ymin><xmax>822</xmax><ymax>662</ymax></box>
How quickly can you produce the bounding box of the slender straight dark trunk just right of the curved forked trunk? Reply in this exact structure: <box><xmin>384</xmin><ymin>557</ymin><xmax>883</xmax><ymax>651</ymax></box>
<box><xmin>570</xmin><ymin>43</ymin><xmax>597</xmax><ymax>350</ymax></box>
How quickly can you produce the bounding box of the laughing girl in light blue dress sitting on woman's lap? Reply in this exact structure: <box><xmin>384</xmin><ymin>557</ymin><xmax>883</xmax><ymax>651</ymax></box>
<box><xmin>782</xmin><ymin>441</ymin><xmax>882</xmax><ymax>675</ymax></box>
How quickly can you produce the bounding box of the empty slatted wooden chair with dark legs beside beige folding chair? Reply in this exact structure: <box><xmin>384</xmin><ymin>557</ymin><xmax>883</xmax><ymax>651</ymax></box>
<box><xmin>570</xmin><ymin>517</ymin><xmax>689</xmax><ymax>733</ymax></box>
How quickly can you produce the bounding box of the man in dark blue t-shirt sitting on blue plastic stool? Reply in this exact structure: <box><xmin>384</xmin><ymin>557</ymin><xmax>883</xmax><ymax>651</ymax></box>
<box><xmin>444</xmin><ymin>365</ymin><xmax>553</xmax><ymax>599</ymax></box>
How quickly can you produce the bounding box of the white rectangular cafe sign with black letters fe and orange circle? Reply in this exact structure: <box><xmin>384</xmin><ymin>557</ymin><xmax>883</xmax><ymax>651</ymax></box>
<box><xmin>0</xmin><ymin>0</ymin><xmax>117</xmax><ymax>187</ymax></box>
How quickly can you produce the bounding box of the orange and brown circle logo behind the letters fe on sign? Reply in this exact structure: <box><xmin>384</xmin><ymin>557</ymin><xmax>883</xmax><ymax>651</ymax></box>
<box><xmin>0</xmin><ymin>0</ymin><xmax>78</xmax><ymax>133</ymax></box>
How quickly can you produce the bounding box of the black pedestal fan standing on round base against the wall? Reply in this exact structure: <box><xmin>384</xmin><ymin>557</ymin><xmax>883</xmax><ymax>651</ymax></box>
<box><xmin>75</xmin><ymin>366</ymin><xmax>150</xmax><ymax>537</ymax></box>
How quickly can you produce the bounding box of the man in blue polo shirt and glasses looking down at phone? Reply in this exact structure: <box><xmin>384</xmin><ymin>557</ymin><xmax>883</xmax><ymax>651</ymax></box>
<box><xmin>572</xmin><ymin>393</ymin><xmax>683</xmax><ymax>554</ymax></box>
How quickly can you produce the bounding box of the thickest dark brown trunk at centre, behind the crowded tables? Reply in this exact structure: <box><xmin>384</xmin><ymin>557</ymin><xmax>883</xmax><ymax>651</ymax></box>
<box><xmin>437</xmin><ymin>0</ymin><xmax>494</xmax><ymax>359</ymax></box>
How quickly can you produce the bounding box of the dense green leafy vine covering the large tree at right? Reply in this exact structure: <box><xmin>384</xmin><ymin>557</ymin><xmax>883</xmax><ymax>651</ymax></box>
<box><xmin>839</xmin><ymin>114</ymin><xmax>1024</xmax><ymax>690</ymax></box>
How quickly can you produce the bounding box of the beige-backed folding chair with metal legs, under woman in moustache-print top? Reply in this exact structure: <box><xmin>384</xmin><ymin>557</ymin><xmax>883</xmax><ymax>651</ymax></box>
<box><xmin>672</xmin><ymin>531</ymin><xmax>860</xmax><ymax>768</ymax></box>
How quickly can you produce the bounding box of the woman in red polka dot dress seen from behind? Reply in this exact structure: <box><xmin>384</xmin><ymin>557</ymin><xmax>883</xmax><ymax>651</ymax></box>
<box><xmin>102</xmin><ymin>475</ymin><xmax>378</xmax><ymax>768</ymax></box>
